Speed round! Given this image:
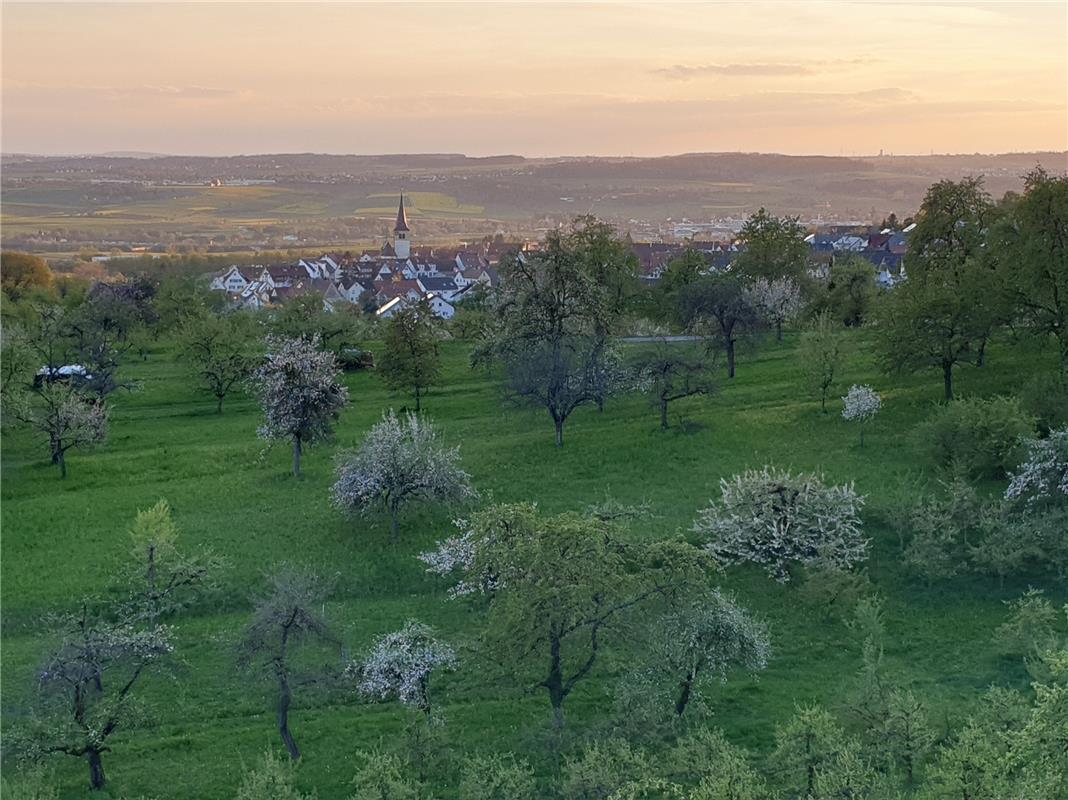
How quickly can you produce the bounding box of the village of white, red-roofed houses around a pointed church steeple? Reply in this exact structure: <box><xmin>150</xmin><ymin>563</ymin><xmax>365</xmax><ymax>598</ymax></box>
<box><xmin>210</xmin><ymin>194</ymin><xmax>915</xmax><ymax>319</ymax></box>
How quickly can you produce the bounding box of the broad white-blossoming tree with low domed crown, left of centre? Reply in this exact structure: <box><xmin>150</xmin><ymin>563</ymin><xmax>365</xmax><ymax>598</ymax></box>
<box><xmin>333</xmin><ymin>409</ymin><xmax>475</xmax><ymax>540</ymax></box>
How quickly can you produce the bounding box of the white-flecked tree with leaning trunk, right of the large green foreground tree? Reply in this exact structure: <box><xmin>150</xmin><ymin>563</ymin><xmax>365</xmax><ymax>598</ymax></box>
<box><xmin>632</xmin><ymin>590</ymin><xmax>771</xmax><ymax>717</ymax></box>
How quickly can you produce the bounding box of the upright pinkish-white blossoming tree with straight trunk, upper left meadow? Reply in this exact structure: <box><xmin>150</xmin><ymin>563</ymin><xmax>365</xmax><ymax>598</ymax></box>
<box><xmin>252</xmin><ymin>338</ymin><xmax>348</xmax><ymax>475</ymax></box>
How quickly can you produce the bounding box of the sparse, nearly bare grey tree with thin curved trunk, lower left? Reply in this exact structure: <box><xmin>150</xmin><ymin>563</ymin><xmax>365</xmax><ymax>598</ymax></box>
<box><xmin>238</xmin><ymin>564</ymin><xmax>339</xmax><ymax>760</ymax></box>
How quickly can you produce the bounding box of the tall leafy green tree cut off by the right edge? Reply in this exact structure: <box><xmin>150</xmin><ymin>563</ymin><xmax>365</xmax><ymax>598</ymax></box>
<box><xmin>990</xmin><ymin>167</ymin><xmax>1068</xmax><ymax>373</ymax></box>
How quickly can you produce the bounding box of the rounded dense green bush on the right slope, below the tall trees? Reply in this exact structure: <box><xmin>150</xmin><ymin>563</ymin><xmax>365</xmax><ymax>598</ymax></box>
<box><xmin>916</xmin><ymin>397</ymin><xmax>1035</xmax><ymax>477</ymax></box>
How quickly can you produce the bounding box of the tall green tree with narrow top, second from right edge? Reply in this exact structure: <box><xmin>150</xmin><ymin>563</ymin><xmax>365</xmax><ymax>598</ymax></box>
<box><xmin>876</xmin><ymin>178</ymin><xmax>1000</xmax><ymax>401</ymax></box>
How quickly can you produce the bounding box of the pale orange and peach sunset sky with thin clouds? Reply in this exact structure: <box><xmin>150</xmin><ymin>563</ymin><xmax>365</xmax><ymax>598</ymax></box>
<box><xmin>0</xmin><ymin>0</ymin><xmax>1068</xmax><ymax>156</ymax></box>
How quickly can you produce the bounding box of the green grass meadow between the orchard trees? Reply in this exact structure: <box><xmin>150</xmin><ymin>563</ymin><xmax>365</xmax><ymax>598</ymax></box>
<box><xmin>0</xmin><ymin>328</ymin><xmax>1068</xmax><ymax>798</ymax></box>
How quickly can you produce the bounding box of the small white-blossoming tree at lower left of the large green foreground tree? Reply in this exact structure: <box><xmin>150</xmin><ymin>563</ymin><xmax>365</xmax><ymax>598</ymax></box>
<box><xmin>346</xmin><ymin>621</ymin><xmax>456</xmax><ymax>719</ymax></box>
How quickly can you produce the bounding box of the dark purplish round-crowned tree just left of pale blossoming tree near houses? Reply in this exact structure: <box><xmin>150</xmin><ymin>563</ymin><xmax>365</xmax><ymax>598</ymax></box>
<box><xmin>678</xmin><ymin>273</ymin><xmax>759</xmax><ymax>378</ymax></box>
